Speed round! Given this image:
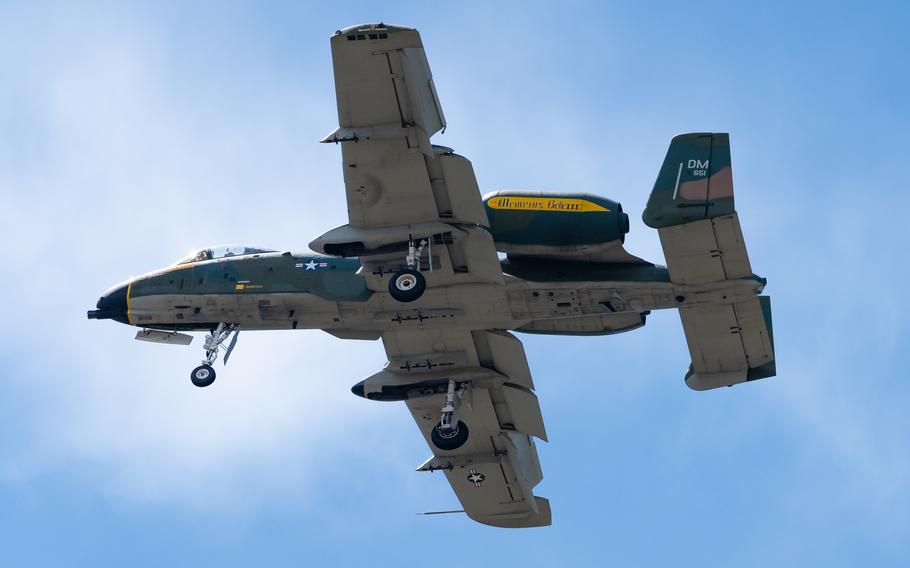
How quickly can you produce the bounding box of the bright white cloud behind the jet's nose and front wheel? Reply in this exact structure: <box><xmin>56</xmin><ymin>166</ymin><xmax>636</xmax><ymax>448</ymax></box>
<box><xmin>0</xmin><ymin>6</ymin><xmax>414</xmax><ymax>510</ymax></box>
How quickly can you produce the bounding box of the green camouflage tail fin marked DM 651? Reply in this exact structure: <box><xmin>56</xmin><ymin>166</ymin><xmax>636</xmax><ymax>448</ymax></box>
<box><xmin>642</xmin><ymin>132</ymin><xmax>734</xmax><ymax>229</ymax></box>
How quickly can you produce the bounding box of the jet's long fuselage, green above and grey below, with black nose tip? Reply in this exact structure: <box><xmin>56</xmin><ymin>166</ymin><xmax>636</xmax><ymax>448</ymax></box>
<box><xmin>89</xmin><ymin>252</ymin><xmax>764</xmax><ymax>339</ymax></box>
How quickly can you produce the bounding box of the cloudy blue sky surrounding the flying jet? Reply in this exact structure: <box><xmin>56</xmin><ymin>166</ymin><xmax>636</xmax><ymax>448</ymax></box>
<box><xmin>0</xmin><ymin>2</ymin><xmax>910</xmax><ymax>566</ymax></box>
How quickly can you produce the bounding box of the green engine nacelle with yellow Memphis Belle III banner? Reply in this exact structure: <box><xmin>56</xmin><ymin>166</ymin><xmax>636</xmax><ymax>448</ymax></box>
<box><xmin>483</xmin><ymin>190</ymin><xmax>629</xmax><ymax>257</ymax></box>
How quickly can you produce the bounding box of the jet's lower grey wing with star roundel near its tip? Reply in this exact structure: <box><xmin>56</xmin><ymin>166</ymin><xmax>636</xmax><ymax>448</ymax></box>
<box><xmin>354</xmin><ymin>328</ymin><xmax>550</xmax><ymax>528</ymax></box>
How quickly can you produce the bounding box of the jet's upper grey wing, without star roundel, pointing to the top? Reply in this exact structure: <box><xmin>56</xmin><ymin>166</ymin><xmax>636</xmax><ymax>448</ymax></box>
<box><xmin>310</xmin><ymin>24</ymin><xmax>502</xmax><ymax>289</ymax></box>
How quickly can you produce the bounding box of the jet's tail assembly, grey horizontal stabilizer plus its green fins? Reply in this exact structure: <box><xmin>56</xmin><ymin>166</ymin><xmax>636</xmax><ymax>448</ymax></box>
<box><xmin>642</xmin><ymin>133</ymin><xmax>777</xmax><ymax>390</ymax></box>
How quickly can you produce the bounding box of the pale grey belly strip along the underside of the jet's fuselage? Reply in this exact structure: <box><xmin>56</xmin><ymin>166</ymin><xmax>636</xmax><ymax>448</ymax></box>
<box><xmin>129</xmin><ymin>278</ymin><xmax>763</xmax><ymax>333</ymax></box>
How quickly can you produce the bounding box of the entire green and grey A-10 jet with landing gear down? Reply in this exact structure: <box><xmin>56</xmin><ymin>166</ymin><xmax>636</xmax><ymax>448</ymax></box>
<box><xmin>88</xmin><ymin>24</ymin><xmax>775</xmax><ymax>527</ymax></box>
